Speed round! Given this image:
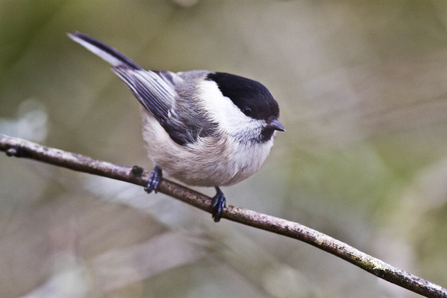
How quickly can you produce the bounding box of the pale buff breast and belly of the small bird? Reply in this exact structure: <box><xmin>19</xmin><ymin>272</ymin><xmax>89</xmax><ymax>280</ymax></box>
<box><xmin>143</xmin><ymin>113</ymin><xmax>273</xmax><ymax>187</ymax></box>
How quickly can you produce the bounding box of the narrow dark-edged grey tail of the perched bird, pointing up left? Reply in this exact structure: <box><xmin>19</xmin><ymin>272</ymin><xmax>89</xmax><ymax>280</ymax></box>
<box><xmin>67</xmin><ymin>32</ymin><xmax>143</xmax><ymax>70</ymax></box>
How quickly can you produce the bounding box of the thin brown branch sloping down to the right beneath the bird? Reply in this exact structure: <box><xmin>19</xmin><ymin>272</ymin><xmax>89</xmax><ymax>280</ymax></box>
<box><xmin>0</xmin><ymin>134</ymin><xmax>447</xmax><ymax>297</ymax></box>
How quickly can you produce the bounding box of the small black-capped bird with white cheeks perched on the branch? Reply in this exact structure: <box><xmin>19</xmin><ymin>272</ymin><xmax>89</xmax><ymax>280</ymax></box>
<box><xmin>68</xmin><ymin>32</ymin><xmax>285</xmax><ymax>222</ymax></box>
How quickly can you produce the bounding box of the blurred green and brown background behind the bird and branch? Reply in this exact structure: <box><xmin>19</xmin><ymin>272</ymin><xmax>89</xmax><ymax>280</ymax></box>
<box><xmin>0</xmin><ymin>0</ymin><xmax>447</xmax><ymax>298</ymax></box>
